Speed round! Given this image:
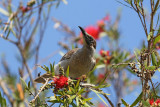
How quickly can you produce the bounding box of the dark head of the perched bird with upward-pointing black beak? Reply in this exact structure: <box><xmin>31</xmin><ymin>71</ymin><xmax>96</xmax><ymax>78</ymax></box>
<box><xmin>78</xmin><ymin>26</ymin><xmax>96</xmax><ymax>49</ymax></box>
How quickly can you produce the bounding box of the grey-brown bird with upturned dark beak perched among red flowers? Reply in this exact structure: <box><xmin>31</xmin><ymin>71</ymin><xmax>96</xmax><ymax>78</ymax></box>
<box><xmin>34</xmin><ymin>26</ymin><xmax>96</xmax><ymax>83</ymax></box>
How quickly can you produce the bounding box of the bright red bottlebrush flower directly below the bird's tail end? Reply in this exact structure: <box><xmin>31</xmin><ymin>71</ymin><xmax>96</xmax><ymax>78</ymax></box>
<box><xmin>53</xmin><ymin>76</ymin><xmax>68</xmax><ymax>89</ymax></box>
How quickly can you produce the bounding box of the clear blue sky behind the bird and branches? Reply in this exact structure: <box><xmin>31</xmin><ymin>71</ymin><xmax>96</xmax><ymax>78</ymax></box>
<box><xmin>0</xmin><ymin>0</ymin><xmax>156</xmax><ymax>103</ymax></box>
